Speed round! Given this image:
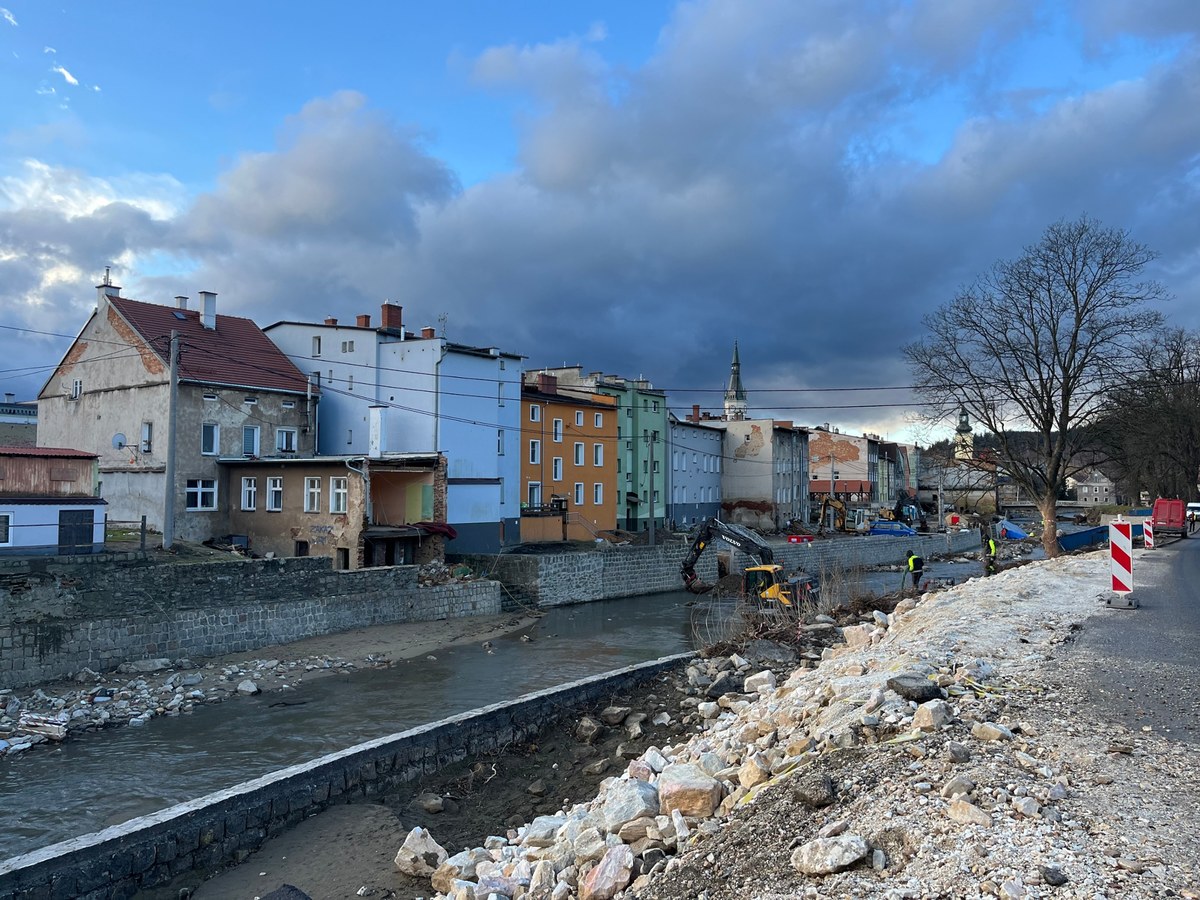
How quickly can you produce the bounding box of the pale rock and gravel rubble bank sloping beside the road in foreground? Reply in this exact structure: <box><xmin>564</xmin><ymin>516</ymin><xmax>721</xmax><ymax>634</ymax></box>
<box><xmin>396</xmin><ymin>556</ymin><xmax>1200</xmax><ymax>900</ymax></box>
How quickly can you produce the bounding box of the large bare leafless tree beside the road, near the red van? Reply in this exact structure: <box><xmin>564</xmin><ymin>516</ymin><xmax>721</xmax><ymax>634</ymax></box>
<box><xmin>905</xmin><ymin>216</ymin><xmax>1165</xmax><ymax>557</ymax></box>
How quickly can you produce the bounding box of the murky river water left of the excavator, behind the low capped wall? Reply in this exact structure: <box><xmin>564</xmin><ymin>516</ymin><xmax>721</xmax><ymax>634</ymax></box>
<box><xmin>0</xmin><ymin>592</ymin><xmax>695</xmax><ymax>859</ymax></box>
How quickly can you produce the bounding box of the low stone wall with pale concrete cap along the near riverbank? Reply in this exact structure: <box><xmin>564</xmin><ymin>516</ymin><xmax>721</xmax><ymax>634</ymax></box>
<box><xmin>0</xmin><ymin>654</ymin><xmax>692</xmax><ymax>900</ymax></box>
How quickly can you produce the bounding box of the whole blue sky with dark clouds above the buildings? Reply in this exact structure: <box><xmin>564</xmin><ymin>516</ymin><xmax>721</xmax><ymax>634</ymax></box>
<box><xmin>0</xmin><ymin>0</ymin><xmax>1200</xmax><ymax>440</ymax></box>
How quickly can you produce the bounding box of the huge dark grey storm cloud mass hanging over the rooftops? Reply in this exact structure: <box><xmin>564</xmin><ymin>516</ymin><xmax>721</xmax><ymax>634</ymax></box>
<box><xmin>0</xmin><ymin>0</ymin><xmax>1200</xmax><ymax>431</ymax></box>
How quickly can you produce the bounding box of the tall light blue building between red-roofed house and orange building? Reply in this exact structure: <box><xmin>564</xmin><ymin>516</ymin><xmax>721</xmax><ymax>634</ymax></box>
<box><xmin>263</xmin><ymin>304</ymin><xmax>524</xmax><ymax>553</ymax></box>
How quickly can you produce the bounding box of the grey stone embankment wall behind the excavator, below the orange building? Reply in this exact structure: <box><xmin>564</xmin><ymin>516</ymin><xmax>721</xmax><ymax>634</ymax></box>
<box><xmin>456</xmin><ymin>532</ymin><xmax>979</xmax><ymax>608</ymax></box>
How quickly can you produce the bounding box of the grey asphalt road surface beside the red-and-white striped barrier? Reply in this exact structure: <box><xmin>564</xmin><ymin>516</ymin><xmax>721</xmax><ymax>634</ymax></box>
<box><xmin>1061</xmin><ymin>534</ymin><xmax>1200</xmax><ymax>744</ymax></box>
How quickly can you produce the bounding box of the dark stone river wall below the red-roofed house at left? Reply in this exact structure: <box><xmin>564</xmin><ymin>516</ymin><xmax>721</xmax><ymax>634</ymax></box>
<box><xmin>0</xmin><ymin>556</ymin><xmax>500</xmax><ymax>688</ymax></box>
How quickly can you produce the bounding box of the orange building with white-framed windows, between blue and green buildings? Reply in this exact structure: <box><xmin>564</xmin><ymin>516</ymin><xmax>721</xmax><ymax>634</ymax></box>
<box><xmin>521</xmin><ymin>372</ymin><xmax>619</xmax><ymax>541</ymax></box>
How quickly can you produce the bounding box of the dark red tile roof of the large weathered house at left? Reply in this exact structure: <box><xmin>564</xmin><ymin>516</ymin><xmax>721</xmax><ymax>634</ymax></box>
<box><xmin>108</xmin><ymin>296</ymin><xmax>317</xmax><ymax>394</ymax></box>
